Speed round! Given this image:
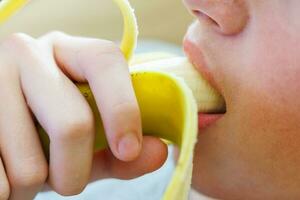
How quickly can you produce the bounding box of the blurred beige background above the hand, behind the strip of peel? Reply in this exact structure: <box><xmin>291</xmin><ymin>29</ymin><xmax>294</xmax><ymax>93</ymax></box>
<box><xmin>0</xmin><ymin>0</ymin><xmax>192</xmax><ymax>44</ymax></box>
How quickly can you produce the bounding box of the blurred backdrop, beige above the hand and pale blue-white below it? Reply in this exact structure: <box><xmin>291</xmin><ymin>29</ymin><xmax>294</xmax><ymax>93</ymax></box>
<box><xmin>0</xmin><ymin>0</ymin><xmax>199</xmax><ymax>200</ymax></box>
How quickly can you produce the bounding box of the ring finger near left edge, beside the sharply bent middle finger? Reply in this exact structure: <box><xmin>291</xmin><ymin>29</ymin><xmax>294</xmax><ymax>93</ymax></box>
<box><xmin>0</xmin><ymin>37</ymin><xmax>47</xmax><ymax>200</ymax></box>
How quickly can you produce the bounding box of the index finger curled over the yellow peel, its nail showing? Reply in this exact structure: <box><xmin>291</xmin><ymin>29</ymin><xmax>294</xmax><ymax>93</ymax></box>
<box><xmin>47</xmin><ymin>34</ymin><xmax>142</xmax><ymax>161</ymax></box>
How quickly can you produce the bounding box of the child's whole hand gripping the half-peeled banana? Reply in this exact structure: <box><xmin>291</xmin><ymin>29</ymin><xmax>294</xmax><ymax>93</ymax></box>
<box><xmin>0</xmin><ymin>32</ymin><xmax>167</xmax><ymax>200</ymax></box>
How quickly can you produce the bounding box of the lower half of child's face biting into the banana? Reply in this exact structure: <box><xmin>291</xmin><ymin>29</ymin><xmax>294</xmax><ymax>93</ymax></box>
<box><xmin>184</xmin><ymin>0</ymin><xmax>300</xmax><ymax>199</ymax></box>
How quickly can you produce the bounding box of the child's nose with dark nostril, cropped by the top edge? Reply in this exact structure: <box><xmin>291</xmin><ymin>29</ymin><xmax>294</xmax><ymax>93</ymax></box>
<box><xmin>184</xmin><ymin>0</ymin><xmax>249</xmax><ymax>35</ymax></box>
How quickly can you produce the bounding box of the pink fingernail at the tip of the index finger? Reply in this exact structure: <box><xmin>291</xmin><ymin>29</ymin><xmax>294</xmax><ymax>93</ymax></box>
<box><xmin>118</xmin><ymin>133</ymin><xmax>140</xmax><ymax>161</ymax></box>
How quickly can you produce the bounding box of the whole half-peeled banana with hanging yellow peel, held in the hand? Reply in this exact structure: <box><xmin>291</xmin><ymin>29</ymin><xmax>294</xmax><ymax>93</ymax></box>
<box><xmin>0</xmin><ymin>0</ymin><xmax>225</xmax><ymax>200</ymax></box>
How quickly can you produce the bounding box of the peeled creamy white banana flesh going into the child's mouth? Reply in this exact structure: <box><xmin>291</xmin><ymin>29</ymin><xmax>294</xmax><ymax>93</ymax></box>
<box><xmin>130</xmin><ymin>53</ymin><xmax>225</xmax><ymax>113</ymax></box>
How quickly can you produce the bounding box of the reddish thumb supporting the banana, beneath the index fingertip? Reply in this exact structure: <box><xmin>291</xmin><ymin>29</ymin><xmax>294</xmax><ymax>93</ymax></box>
<box><xmin>91</xmin><ymin>136</ymin><xmax>168</xmax><ymax>181</ymax></box>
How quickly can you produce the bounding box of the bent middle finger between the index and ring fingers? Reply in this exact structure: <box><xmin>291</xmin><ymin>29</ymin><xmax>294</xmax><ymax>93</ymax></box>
<box><xmin>16</xmin><ymin>33</ymin><xmax>94</xmax><ymax>195</ymax></box>
